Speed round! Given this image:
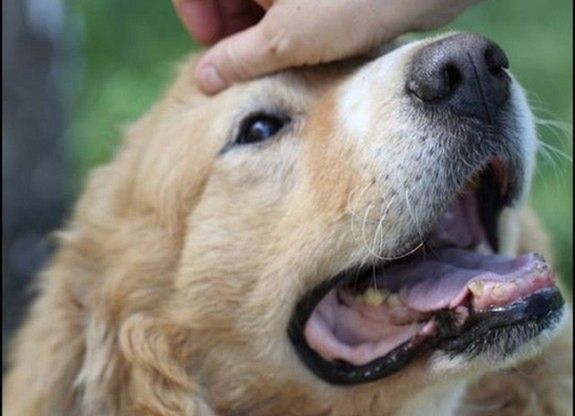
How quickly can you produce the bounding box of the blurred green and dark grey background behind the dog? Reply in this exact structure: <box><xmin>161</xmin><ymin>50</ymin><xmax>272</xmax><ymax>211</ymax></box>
<box><xmin>2</xmin><ymin>0</ymin><xmax>573</xmax><ymax>347</ymax></box>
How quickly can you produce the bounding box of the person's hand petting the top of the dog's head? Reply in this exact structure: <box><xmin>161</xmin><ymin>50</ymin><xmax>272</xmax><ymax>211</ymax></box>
<box><xmin>173</xmin><ymin>0</ymin><xmax>479</xmax><ymax>93</ymax></box>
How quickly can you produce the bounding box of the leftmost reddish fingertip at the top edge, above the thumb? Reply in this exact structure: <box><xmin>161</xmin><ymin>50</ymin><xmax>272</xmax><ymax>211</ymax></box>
<box><xmin>173</xmin><ymin>0</ymin><xmax>224</xmax><ymax>45</ymax></box>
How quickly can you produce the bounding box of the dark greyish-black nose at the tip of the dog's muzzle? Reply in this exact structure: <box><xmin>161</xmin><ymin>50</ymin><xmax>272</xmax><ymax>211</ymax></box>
<box><xmin>407</xmin><ymin>34</ymin><xmax>510</xmax><ymax>124</ymax></box>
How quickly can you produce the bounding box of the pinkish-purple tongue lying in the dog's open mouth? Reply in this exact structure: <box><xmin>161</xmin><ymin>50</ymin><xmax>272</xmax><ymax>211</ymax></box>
<box><xmin>381</xmin><ymin>248</ymin><xmax>548</xmax><ymax>312</ymax></box>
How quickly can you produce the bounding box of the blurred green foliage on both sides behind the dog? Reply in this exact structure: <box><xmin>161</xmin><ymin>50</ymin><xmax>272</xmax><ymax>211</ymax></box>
<box><xmin>68</xmin><ymin>0</ymin><xmax>573</xmax><ymax>285</ymax></box>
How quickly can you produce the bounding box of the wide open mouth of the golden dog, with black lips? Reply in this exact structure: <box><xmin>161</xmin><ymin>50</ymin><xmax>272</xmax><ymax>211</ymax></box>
<box><xmin>289</xmin><ymin>158</ymin><xmax>563</xmax><ymax>384</ymax></box>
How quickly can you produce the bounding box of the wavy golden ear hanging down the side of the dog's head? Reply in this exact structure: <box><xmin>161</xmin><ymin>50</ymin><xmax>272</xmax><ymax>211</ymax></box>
<box><xmin>68</xmin><ymin>122</ymin><xmax>218</xmax><ymax>416</ymax></box>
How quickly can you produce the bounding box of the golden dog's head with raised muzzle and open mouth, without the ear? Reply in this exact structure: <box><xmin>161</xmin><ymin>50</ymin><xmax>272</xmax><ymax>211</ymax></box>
<box><xmin>90</xmin><ymin>34</ymin><xmax>564</xmax><ymax>414</ymax></box>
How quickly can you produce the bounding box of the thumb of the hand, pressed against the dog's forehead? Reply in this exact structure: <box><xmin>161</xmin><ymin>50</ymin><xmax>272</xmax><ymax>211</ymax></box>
<box><xmin>195</xmin><ymin>18</ymin><xmax>299</xmax><ymax>94</ymax></box>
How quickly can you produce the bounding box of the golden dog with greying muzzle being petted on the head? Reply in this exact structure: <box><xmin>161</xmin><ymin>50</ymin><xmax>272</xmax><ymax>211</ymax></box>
<box><xmin>3</xmin><ymin>33</ymin><xmax>572</xmax><ymax>416</ymax></box>
